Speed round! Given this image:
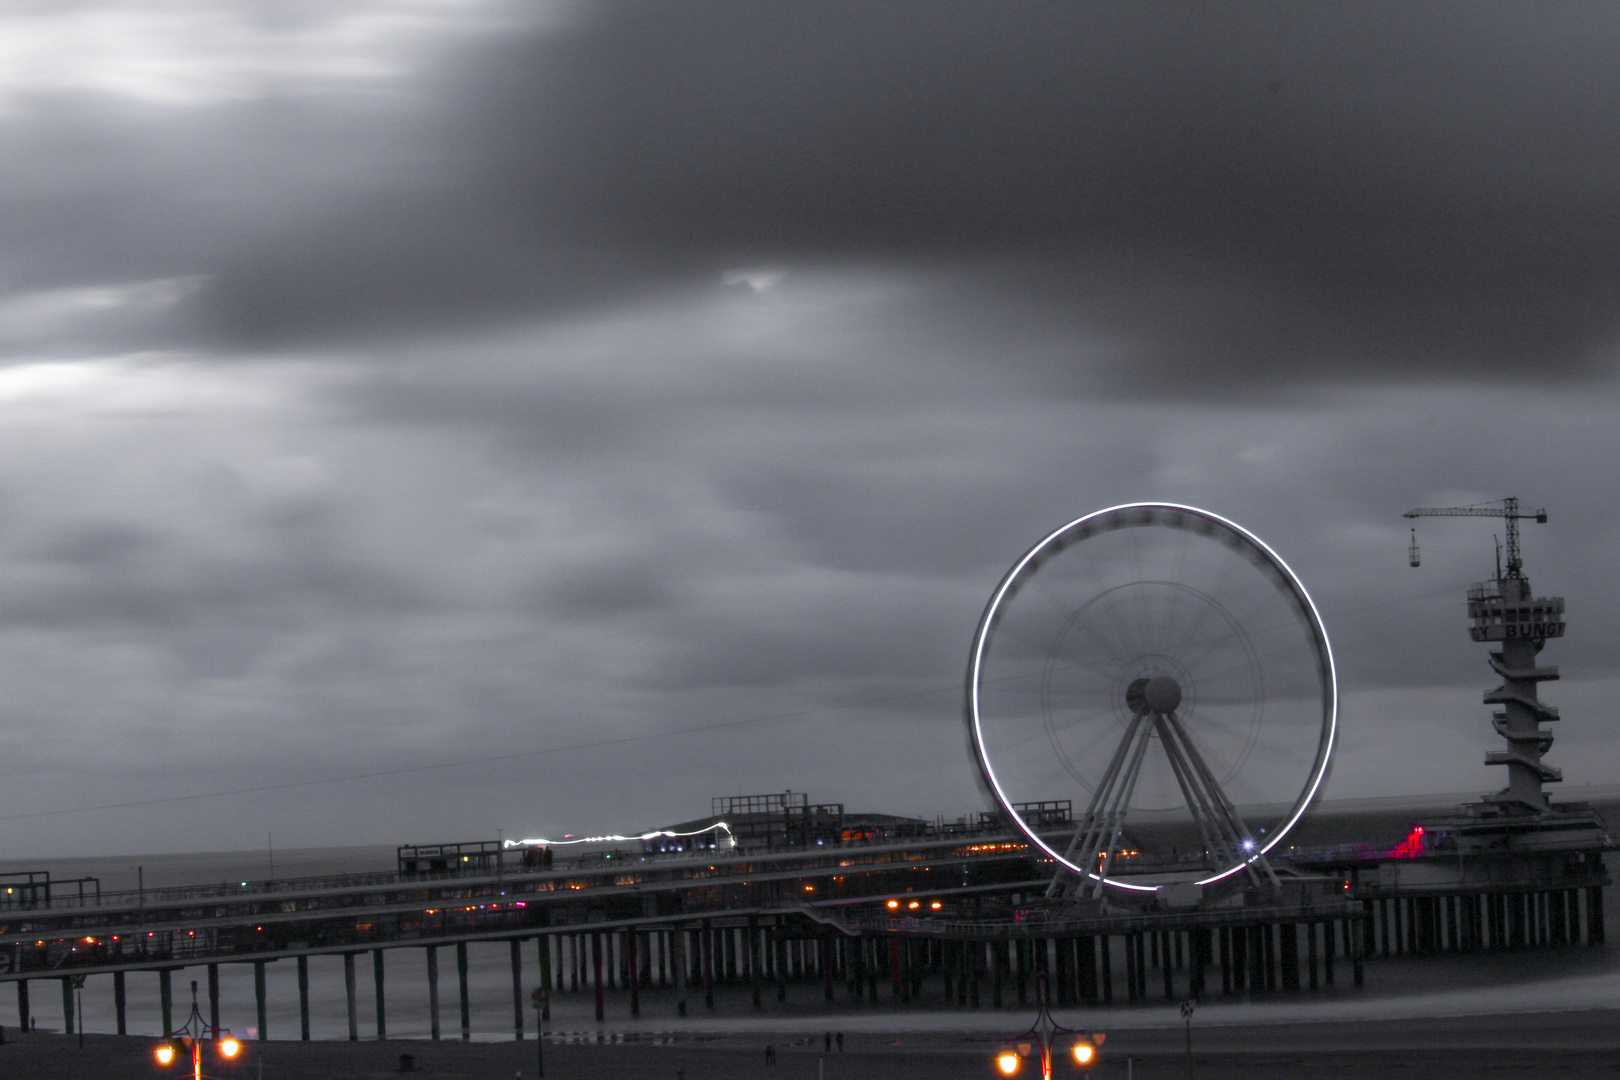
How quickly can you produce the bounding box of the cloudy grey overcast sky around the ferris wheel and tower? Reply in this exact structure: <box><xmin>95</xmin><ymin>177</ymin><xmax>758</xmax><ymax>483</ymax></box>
<box><xmin>0</xmin><ymin>0</ymin><xmax>1620</xmax><ymax>858</ymax></box>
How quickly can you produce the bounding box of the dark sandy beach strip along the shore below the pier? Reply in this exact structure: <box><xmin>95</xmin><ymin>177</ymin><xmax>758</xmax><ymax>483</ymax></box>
<box><xmin>9</xmin><ymin>1009</ymin><xmax>1620</xmax><ymax>1080</ymax></box>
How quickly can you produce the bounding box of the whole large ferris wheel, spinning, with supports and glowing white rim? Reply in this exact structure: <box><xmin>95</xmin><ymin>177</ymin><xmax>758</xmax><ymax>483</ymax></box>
<box><xmin>967</xmin><ymin>502</ymin><xmax>1338</xmax><ymax>894</ymax></box>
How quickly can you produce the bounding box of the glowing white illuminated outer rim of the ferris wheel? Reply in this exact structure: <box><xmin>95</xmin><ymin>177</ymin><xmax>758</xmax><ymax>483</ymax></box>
<box><xmin>967</xmin><ymin>502</ymin><xmax>1338</xmax><ymax>892</ymax></box>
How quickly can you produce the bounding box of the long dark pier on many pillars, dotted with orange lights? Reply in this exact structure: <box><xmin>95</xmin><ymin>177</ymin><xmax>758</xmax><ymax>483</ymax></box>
<box><xmin>0</xmin><ymin>799</ymin><xmax>1607</xmax><ymax>1040</ymax></box>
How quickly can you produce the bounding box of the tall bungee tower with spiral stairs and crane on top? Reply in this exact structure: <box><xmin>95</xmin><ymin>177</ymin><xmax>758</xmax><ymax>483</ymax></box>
<box><xmin>1403</xmin><ymin>495</ymin><xmax>1565</xmax><ymax>813</ymax></box>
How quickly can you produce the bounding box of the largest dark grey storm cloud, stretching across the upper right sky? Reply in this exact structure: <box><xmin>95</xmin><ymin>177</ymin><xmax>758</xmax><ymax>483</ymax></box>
<box><xmin>202</xmin><ymin>0</ymin><xmax>1620</xmax><ymax>387</ymax></box>
